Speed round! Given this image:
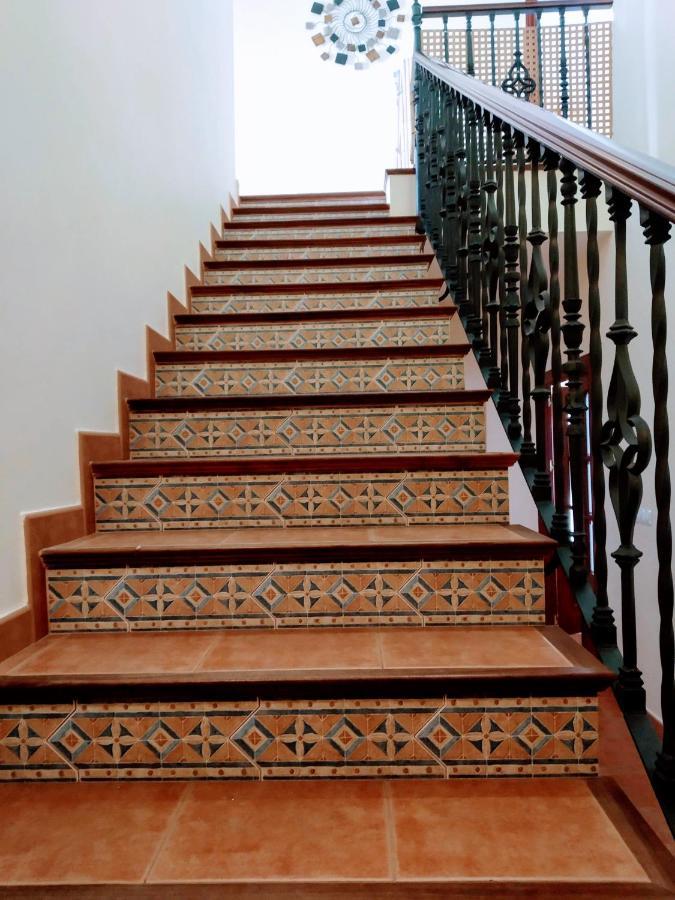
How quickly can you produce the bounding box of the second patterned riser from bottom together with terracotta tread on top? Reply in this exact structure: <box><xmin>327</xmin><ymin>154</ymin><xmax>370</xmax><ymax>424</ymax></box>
<box><xmin>42</xmin><ymin>525</ymin><xmax>555</xmax><ymax>632</ymax></box>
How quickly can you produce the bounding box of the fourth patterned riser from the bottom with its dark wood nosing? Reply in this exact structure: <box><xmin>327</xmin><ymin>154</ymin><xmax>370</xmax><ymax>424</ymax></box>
<box><xmin>128</xmin><ymin>391</ymin><xmax>490</xmax><ymax>459</ymax></box>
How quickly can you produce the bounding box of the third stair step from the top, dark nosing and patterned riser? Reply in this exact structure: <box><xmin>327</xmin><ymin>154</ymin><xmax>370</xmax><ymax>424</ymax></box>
<box><xmin>223</xmin><ymin>215</ymin><xmax>417</xmax><ymax>241</ymax></box>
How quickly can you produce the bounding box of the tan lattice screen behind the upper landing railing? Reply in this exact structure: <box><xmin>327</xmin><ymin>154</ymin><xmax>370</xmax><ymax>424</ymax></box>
<box><xmin>422</xmin><ymin>22</ymin><xmax>612</xmax><ymax>137</ymax></box>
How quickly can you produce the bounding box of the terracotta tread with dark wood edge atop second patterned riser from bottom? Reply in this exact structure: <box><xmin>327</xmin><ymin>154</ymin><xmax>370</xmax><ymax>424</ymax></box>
<box><xmin>41</xmin><ymin>524</ymin><xmax>555</xmax><ymax>560</ymax></box>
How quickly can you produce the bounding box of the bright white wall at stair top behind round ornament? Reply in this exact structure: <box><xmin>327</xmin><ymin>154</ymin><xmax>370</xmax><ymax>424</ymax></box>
<box><xmin>234</xmin><ymin>0</ymin><xmax>412</xmax><ymax>194</ymax></box>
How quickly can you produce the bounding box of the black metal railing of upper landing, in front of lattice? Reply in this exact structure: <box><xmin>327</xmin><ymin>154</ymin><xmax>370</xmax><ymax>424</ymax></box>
<box><xmin>420</xmin><ymin>0</ymin><xmax>613</xmax><ymax>135</ymax></box>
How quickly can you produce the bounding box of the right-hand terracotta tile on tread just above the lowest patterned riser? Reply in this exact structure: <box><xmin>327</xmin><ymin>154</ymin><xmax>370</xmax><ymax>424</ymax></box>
<box><xmin>381</xmin><ymin>627</ymin><xmax>570</xmax><ymax>669</ymax></box>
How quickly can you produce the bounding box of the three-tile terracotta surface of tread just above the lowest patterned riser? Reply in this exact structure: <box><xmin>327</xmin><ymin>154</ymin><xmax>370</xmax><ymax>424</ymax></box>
<box><xmin>0</xmin><ymin>626</ymin><xmax>580</xmax><ymax>676</ymax></box>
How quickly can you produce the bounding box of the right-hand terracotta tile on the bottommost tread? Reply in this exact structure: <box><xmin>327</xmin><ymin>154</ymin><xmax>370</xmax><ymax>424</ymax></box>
<box><xmin>389</xmin><ymin>779</ymin><xmax>648</xmax><ymax>882</ymax></box>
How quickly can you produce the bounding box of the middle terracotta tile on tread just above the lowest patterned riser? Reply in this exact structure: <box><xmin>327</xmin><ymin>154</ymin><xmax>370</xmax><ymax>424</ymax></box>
<box><xmin>199</xmin><ymin>628</ymin><xmax>380</xmax><ymax>671</ymax></box>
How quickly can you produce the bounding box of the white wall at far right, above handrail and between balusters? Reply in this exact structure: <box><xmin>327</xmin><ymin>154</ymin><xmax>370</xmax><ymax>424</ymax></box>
<box><xmin>602</xmin><ymin>0</ymin><xmax>675</xmax><ymax>715</ymax></box>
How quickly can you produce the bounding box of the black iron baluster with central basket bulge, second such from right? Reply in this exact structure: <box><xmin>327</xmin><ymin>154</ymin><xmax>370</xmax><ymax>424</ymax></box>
<box><xmin>523</xmin><ymin>140</ymin><xmax>551</xmax><ymax>500</ymax></box>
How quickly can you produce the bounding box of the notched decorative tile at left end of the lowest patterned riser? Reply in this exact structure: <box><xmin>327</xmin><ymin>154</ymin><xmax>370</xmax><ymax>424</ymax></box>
<box><xmin>0</xmin><ymin>704</ymin><xmax>76</xmax><ymax>781</ymax></box>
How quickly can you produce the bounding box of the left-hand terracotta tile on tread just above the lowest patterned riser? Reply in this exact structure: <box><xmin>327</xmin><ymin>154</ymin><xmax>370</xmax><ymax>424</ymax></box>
<box><xmin>12</xmin><ymin>634</ymin><xmax>215</xmax><ymax>675</ymax></box>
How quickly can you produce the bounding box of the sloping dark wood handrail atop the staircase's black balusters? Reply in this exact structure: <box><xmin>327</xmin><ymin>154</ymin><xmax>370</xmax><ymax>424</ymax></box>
<box><xmin>415</xmin><ymin>52</ymin><xmax>675</xmax><ymax>222</ymax></box>
